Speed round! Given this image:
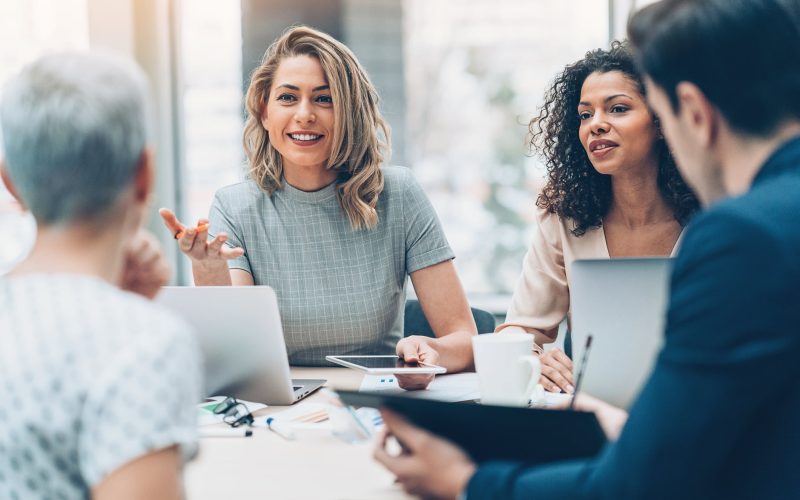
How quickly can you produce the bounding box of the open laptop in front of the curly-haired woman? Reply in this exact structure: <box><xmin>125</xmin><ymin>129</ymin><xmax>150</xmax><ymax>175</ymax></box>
<box><xmin>570</xmin><ymin>258</ymin><xmax>672</xmax><ymax>408</ymax></box>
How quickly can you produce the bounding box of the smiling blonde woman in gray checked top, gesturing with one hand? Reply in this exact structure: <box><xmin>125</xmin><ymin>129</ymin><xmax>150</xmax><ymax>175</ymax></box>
<box><xmin>161</xmin><ymin>27</ymin><xmax>476</xmax><ymax>388</ymax></box>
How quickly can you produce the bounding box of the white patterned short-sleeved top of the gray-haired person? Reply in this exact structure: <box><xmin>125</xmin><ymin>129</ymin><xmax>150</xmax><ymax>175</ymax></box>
<box><xmin>0</xmin><ymin>274</ymin><xmax>202</xmax><ymax>499</ymax></box>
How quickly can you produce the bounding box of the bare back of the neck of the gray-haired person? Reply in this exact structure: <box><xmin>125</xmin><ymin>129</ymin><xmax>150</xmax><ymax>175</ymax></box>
<box><xmin>10</xmin><ymin>222</ymin><xmax>129</xmax><ymax>285</ymax></box>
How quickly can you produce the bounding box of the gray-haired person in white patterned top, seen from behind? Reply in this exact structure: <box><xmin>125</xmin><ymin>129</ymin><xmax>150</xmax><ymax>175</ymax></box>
<box><xmin>0</xmin><ymin>53</ymin><xmax>201</xmax><ymax>499</ymax></box>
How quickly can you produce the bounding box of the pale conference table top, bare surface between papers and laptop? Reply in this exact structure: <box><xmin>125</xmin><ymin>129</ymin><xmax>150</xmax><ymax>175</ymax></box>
<box><xmin>185</xmin><ymin>368</ymin><xmax>410</xmax><ymax>500</ymax></box>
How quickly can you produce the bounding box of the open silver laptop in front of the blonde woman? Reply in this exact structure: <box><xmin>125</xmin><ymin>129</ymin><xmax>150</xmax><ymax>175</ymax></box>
<box><xmin>156</xmin><ymin>286</ymin><xmax>326</xmax><ymax>405</ymax></box>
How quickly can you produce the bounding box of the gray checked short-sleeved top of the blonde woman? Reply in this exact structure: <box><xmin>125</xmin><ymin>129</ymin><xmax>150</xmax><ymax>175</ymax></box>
<box><xmin>209</xmin><ymin>167</ymin><xmax>454</xmax><ymax>366</ymax></box>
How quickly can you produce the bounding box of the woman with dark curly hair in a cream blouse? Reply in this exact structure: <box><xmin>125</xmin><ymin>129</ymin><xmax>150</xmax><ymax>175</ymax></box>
<box><xmin>497</xmin><ymin>42</ymin><xmax>698</xmax><ymax>393</ymax></box>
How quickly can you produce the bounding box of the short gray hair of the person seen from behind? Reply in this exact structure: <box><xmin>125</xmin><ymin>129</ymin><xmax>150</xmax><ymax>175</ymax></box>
<box><xmin>0</xmin><ymin>52</ymin><xmax>147</xmax><ymax>224</ymax></box>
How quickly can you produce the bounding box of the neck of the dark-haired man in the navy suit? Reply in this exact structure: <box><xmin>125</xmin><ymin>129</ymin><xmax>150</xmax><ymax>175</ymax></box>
<box><xmin>719</xmin><ymin>121</ymin><xmax>800</xmax><ymax>196</ymax></box>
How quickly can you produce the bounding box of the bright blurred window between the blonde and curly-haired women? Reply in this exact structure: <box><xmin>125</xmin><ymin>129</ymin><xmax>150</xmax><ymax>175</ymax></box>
<box><xmin>404</xmin><ymin>0</ymin><xmax>608</xmax><ymax>296</ymax></box>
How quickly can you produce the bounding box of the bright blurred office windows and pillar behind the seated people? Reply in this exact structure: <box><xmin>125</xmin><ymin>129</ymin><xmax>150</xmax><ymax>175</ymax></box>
<box><xmin>0</xmin><ymin>0</ymin><xmax>651</xmax><ymax>315</ymax></box>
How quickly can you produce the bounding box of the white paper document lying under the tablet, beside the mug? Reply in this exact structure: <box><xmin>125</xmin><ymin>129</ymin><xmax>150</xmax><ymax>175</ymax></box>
<box><xmin>358</xmin><ymin>373</ymin><xmax>481</xmax><ymax>402</ymax></box>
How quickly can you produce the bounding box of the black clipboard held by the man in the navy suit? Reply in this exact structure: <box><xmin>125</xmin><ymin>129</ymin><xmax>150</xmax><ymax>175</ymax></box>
<box><xmin>337</xmin><ymin>391</ymin><xmax>607</xmax><ymax>464</ymax></box>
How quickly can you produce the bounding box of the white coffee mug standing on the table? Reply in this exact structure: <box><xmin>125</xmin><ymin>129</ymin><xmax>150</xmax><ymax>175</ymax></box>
<box><xmin>472</xmin><ymin>333</ymin><xmax>542</xmax><ymax>406</ymax></box>
